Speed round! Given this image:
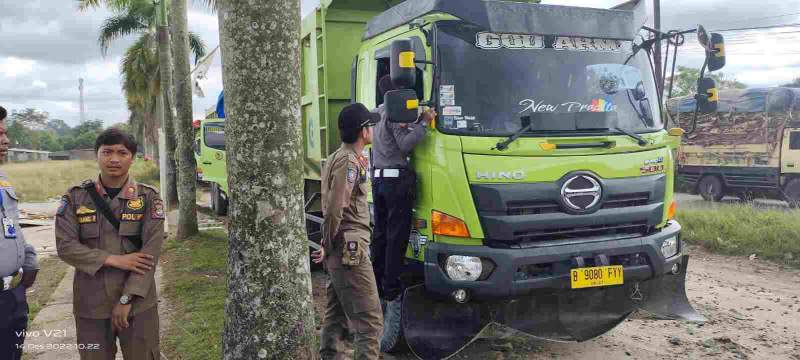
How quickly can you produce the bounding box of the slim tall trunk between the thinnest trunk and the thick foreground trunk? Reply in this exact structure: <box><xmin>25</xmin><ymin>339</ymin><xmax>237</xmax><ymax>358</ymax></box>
<box><xmin>170</xmin><ymin>0</ymin><xmax>198</xmax><ymax>240</ymax></box>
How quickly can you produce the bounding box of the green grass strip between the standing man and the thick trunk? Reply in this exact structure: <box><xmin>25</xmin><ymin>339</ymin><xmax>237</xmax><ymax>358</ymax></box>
<box><xmin>161</xmin><ymin>231</ymin><xmax>228</xmax><ymax>359</ymax></box>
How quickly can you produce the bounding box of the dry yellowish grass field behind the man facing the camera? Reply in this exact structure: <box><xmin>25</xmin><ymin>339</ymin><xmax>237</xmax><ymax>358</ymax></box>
<box><xmin>0</xmin><ymin>160</ymin><xmax>160</xmax><ymax>202</ymax></box>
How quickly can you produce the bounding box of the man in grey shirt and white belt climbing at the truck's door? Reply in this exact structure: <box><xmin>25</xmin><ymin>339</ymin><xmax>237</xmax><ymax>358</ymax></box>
<box><xmin>371</xmin><ymin>75</ymin><xmax>436</xmax><ymax>301</ymax></box>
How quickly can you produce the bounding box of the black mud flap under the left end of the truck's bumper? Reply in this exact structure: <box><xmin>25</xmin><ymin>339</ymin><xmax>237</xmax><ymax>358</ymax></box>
<box><xmin>402</xmin><ymin>285</ymin><xmax>491</xmax><ymax>360</ymax></box>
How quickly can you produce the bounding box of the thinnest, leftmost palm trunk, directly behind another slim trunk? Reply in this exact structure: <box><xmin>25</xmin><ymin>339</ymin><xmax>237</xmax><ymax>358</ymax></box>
<box><xmin>158</xmin><ymin>26</ymin><xmax>178</xmax><ymax>208</ymax></box>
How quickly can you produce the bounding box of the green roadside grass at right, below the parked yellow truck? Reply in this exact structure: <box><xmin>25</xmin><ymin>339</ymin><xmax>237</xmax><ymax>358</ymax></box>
<box><xmin>676</xmin><ymin>204</ymin><xmax>800</xmax><ymax>265</ymax></box>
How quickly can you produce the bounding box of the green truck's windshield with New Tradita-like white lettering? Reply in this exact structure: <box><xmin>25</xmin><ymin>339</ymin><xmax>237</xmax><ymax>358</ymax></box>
<box><xmin>436</xmin><ymin>21</ymin><xmax>663</xmax><ymax>136</ymax></box>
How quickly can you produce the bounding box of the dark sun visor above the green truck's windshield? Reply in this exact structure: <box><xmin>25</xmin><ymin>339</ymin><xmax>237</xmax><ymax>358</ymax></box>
<box><xmin>364</xmin><ymin>0</ymin><xmax>641</xmax><ymax>40</ymax></box>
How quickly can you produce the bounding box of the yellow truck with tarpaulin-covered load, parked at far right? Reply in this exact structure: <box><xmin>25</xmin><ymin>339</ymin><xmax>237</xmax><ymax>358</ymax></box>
<box><xmin>667</xmin><ymin>87</ymin><xmax>800</xmax><ymax>207</ymax></box>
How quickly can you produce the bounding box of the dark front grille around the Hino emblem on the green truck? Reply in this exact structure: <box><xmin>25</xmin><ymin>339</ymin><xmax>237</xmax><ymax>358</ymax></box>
<box><xmin>471</xmin><ymin>174</ymin><xmax>666</xmax><ymax>247</ymax></box>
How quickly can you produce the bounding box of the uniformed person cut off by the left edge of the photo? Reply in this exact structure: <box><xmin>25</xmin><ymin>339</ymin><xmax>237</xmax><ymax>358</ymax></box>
<box><xmin>0</xmin><ymin>107</ymin><xmax>39</xmax><ymax>360</ymax></box>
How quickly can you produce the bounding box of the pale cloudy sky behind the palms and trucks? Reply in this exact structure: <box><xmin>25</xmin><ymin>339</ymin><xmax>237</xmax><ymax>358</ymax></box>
<box><xmin>0</xmin><ymin>0</ymin><xmax>800</xmax><ymax>126</ymax></box>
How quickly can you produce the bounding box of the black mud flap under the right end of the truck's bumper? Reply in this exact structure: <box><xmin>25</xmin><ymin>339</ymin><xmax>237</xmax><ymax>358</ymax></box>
<box><xmin>638</xmin><ymin>255</ymin><xmax>706</xmax><ymax>322</ymax></box>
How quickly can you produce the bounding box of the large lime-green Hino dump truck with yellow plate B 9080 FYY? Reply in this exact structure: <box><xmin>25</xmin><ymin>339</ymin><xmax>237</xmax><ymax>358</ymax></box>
<box><xmin>197</xmin><ymin>0</ymin><xmax>724</xmax><ymax>359</ymax></box>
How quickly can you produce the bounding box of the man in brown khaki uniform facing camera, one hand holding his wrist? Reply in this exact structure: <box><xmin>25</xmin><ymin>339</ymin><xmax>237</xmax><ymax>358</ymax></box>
<box><xmin>56</xmin><ymin>129</ymin><xmax>164</xmax><ymax>360</ymax></box>
